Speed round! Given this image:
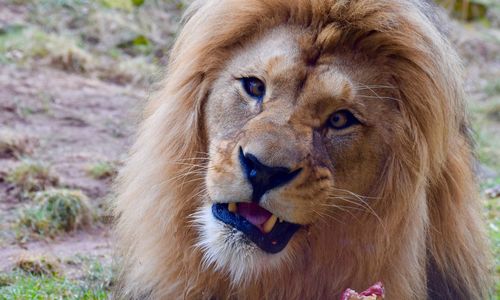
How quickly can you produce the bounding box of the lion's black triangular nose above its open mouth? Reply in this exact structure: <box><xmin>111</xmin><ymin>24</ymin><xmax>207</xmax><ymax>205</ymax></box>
<box><xmin>240</xmin><ymin>147</ymin><xmax>302</xmax><ymax>202</ymax></box>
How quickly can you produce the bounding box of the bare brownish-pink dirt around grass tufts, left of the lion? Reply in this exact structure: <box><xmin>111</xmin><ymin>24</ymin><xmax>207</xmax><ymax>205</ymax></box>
<box><xmin>0</xmin><ymin>66</ymin><xmax>146</xmax><ymax>271</ymax></box>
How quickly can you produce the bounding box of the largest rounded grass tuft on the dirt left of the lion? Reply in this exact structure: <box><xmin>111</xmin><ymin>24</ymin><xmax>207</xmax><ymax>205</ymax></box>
<box><xmin>17</xmin><ymin>189</ymin><xmax>92</xmax><ymax>240</ymax></box>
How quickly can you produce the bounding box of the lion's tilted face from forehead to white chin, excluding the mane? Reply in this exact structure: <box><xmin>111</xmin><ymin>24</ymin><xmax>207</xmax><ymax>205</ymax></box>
<box><xmin>197</xmin><ymin>27</ymin><xmax>401</xmax><ymax>280</ymax></box>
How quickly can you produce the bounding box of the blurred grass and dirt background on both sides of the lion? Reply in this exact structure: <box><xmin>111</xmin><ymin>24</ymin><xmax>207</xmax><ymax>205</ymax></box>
<box><xmin>0</xmin><ymin>0</ymin><xmax>500</xmax><ymax>299</ymax></box>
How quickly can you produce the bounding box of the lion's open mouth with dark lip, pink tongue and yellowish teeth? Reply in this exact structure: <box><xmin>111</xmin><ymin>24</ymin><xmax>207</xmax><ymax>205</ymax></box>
<box><xmin>212</xmin><ymin>202</ymin><xmax>300</xmax><ymax>253</ymax></box>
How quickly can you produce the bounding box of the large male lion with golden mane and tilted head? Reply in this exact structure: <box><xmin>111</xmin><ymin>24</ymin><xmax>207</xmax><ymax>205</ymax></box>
<box><xmin>114</xmin><ymin>0</ymin><xmax>490</xmax><ymax>299</ymax></box>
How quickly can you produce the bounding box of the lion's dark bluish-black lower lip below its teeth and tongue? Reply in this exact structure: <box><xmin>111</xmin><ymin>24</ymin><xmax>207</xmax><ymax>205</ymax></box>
<box><xmin>212</xmin><ymin>203</ymin><xmax>300</xmax><ymax>254</ymax></box>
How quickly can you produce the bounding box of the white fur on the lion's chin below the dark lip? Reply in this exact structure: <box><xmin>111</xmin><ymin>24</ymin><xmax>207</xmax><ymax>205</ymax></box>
<box><xmin>193</xmin><ymin>205</ymin><xmax>291</xmax><ymax>285</ymax></box>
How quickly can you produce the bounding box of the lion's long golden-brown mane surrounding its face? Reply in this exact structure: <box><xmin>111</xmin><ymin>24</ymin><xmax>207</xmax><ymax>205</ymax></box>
<box><xmin>115</xmin><ymin>0</ymin><xmax>490</xmax><ymax>299</ymax></box>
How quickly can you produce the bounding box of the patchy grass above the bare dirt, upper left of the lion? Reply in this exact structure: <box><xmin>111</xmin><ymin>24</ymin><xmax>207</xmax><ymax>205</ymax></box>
<box><xmin>0</xmin><ymin>0</ymin><xmax>180</xmax><ymax>85</ymax></box>
